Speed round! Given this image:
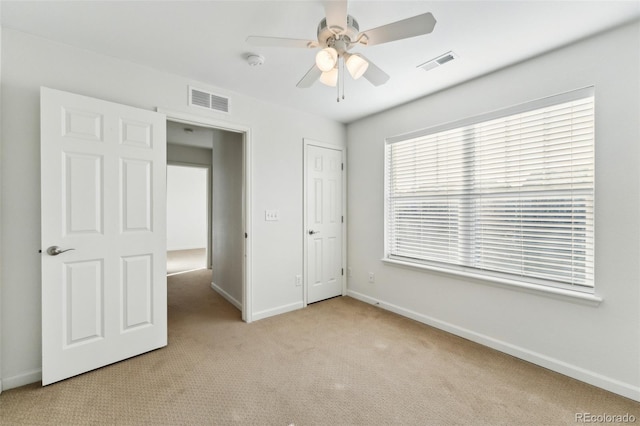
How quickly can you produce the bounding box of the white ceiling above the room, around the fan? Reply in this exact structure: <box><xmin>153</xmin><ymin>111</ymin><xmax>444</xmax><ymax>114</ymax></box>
<box><xmin>0</xmin><ymin>0</ymin><xmax>640</xmax><ymax>123</ymax></box>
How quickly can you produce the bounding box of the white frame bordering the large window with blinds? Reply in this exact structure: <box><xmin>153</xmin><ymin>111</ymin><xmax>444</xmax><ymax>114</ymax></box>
<box><xmin>382</xmin><ymin>86</ymin><xmax>602</xmax><ymax>304</ymax></box>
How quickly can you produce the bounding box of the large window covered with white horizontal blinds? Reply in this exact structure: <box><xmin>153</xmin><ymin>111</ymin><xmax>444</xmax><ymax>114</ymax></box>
<box><xmin>385</xmin><ymin>88</ymin><xmax>594</xmax><ymax>292</ymax></box>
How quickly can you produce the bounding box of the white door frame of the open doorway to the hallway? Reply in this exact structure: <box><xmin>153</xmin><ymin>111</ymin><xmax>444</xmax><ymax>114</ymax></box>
<box><xmin>157</xmin><ymin>108</ymin><xmax>253</xmax><ymax>323</ymax></box>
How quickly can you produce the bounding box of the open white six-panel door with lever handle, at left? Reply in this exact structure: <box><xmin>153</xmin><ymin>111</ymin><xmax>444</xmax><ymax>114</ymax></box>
<box><xmin>41</xmin><ymin>88</ymin><xmax>167</xmax><ymax>385</ymax></box>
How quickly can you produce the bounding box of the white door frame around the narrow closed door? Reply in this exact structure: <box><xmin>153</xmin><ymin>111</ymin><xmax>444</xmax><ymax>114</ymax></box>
<box><xmin>302</xmin><ymin>138</ymin><xmax>349</xmax><ymax>308</ymax></box>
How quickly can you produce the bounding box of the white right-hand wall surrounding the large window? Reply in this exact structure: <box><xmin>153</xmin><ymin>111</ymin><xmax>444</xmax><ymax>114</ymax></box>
<box><xmin>347</xmin><ymin>23</ymin><xmax>640</xmax><ymax>400</ymax></box>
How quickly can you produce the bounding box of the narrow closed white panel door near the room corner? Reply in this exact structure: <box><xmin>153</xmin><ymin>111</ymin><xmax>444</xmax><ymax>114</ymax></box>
<box><xmin>305</xmin><ymin>145</ymin><xmax>344</xmax><ymax>303</ymax></box>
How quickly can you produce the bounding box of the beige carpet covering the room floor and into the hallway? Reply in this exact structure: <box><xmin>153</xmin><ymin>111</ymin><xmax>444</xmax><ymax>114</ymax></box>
<box><xmin>0</xmin><ymin>270</ymin><xmax>640</xmax><ymax>426</ymax></box>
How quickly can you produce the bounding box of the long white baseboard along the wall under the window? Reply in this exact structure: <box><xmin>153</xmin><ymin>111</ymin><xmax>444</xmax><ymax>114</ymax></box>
<box><xmin>347</xmin><ymin>290</ymin><xmax>640</xmax><ymax>401</ymax></box>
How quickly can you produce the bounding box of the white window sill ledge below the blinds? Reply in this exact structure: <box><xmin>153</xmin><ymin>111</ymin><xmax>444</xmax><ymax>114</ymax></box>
<box><xmin>381</xmin><ymin>258</ymin><xmax>603</xmax><ymax>306</ymax></box>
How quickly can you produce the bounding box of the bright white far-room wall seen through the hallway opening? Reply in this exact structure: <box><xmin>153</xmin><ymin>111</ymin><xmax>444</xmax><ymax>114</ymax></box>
<box><xmin>167</xmin><ymin>165</ymin><xmax>208</xmax><ymax>250</ymax></box>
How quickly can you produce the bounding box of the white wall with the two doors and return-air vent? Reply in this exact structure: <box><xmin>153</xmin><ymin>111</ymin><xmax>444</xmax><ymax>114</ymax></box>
<box><xmin>0</xmin><ymin>28</ymin><xmax>345</xmax><ymax>388</ymax></box>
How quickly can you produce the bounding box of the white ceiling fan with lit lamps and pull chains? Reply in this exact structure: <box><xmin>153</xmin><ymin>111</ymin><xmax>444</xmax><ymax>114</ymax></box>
<box><xmin>247</xmin><ymin>0</ymin><xmax>436</xmax><ymax>102</ymax></box>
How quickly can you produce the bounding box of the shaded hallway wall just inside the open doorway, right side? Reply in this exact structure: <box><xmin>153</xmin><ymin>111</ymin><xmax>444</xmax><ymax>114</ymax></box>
<box><xmin>212</xmin><ymin>132</ymin><xmax>246</xmax><ymax>308</ymax></box>
